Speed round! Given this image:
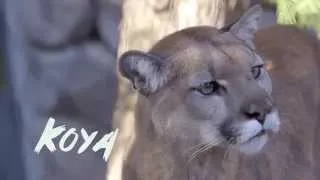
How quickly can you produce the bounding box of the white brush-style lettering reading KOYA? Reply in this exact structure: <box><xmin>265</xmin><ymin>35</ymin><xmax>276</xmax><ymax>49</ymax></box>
<box><xmin>34</xmin><ymin>118</ymin><xmax>118</xmax><ymax>161</ymax></box>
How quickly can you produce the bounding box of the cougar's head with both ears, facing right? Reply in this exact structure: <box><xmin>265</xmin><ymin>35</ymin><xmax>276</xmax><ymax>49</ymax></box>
<box><xmin>119</xmin><ymin>6</ymin><xmax>280</xmax><ymax>154</ymax></box>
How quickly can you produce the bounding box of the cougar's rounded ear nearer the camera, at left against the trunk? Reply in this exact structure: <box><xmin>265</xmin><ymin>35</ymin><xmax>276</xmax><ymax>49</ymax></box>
<box><xmin>119</xmin><ymin>51</ymin><xmax>167</xmax><ymax>96</ymax></box>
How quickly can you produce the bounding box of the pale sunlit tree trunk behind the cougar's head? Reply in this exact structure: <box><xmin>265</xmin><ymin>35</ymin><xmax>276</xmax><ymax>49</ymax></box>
<box><xmin>107</xmin><ymin>0</ymin><xmax>250</xmax><ymax>180</ymax></box>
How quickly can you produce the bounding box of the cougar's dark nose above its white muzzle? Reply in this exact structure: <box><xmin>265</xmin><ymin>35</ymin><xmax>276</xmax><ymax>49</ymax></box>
<box><xmin>242</xmin><ymin>100</ymin><xmax>272</xmax><ymax>125</ymax></box>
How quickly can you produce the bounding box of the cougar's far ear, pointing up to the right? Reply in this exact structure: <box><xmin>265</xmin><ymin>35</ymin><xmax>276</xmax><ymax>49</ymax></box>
<box><xmin>230</xmin><ymin>5</ymin><xmax>262</xmax><ymax>42</ymax></box>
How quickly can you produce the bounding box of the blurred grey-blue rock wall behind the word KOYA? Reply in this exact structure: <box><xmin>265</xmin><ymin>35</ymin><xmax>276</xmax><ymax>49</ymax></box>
<box><xmin>5</xmin><ymin>0</ymin><xmax>121</xmax><ymax>180</ymax></box>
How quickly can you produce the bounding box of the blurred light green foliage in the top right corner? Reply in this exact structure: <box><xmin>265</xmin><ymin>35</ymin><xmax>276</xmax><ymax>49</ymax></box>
<box><xmin>268</xmin><ymin>0</ymin><xmax>320</xmax><ymax>33</ymax></box>
